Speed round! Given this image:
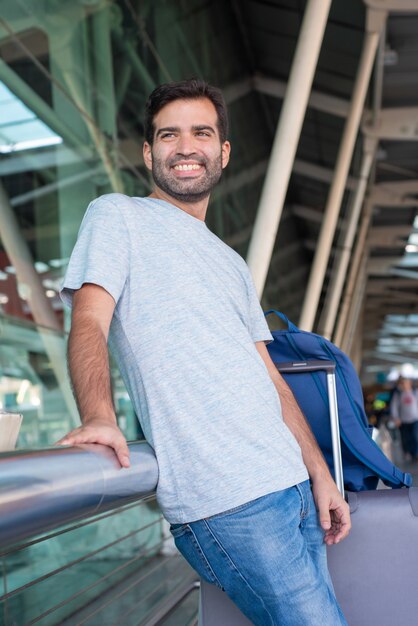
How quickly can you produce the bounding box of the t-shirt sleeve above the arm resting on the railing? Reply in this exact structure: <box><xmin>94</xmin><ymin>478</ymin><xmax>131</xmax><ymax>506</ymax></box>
<box><xmin>60</xmin><ymin>197</ymin><xmax>129</xmax><ymax>306</ymax></box>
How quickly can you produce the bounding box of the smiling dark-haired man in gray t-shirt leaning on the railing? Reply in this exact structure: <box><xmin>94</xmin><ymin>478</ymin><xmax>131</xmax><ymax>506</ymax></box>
<box><xmin>61</xmin><ymin>80</ymin><xmax>350</xmax><ymax>626</ymax></box>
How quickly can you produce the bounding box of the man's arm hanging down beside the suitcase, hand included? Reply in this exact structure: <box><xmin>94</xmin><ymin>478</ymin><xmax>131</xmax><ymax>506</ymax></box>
<box><xmin>255</xmin><ymin>341</ymin><xmax>351</xmax><ymax>545</ymax></box>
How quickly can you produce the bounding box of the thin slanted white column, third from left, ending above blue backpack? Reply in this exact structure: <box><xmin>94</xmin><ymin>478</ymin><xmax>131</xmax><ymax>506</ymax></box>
<box><xmin>321</xmin><ymin>138</ymin><xmax>377</xmax><ymax>339</ymax></box>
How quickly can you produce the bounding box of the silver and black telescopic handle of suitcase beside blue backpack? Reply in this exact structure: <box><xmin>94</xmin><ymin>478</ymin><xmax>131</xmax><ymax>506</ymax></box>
<box><xmin>275</xmin><ymin>360</ymin><xmax>344</xmax><ymax>495</ymax></box>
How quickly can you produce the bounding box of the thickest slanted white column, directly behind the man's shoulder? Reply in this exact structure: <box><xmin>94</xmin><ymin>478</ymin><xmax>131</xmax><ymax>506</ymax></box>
<box><xmin>247</xmin><ymin>0</ymin><xmax>331</xmax><ymax>297</ymax></box>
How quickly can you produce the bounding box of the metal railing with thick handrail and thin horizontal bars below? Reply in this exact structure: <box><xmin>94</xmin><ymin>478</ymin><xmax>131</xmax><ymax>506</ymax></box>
<box><xmin>0</xmin><ymin>442</ymin><xmax>198</xmax><ymax>626</ymax></box>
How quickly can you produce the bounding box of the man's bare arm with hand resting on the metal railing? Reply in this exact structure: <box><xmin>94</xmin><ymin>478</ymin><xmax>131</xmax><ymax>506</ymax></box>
<box><xmin>58</xmin><ymin>283</ymin><xmax>129</xmax><ymax>467</ymax></box>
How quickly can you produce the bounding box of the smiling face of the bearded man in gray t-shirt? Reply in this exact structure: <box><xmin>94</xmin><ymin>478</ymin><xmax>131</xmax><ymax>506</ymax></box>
<box><xmin>144</xmin><ymin>98</ymin><xmax>230</xmax><ymax>203</ymax></box>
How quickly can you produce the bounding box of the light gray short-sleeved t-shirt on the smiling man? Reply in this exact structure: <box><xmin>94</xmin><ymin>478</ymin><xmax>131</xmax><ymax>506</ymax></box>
<box><xmin>62</xmin><ymin>194</ymin><xmax>308</xmax><ymax>523</ymax></box>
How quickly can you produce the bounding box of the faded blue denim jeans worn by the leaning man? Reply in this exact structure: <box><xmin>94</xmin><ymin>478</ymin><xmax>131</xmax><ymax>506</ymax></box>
<box><xmin>171</xmin><ymin>481</ymin><xmax>347</xmax><ymax>626</ymax></box>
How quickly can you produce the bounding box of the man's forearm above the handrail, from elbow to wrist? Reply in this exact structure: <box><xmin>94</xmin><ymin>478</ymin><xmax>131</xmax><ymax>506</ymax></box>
<box><xmin>68</xmin><ymin>314</ymin><xmax>116</xmax><ymax>423</ymax></box>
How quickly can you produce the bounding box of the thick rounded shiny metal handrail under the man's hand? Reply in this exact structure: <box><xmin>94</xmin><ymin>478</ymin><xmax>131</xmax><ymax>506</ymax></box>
<box><xmin>0</xmin><ymin>441</ymin><xmax>158</xmax><ymax>547</ymax></box>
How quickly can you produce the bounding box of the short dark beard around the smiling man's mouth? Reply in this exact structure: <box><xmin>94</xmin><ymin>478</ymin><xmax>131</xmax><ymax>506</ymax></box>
<box><xmin>152</xmin><ymin>153</ymin><xmax>222</xmax><ymax>203</ymax></box>
